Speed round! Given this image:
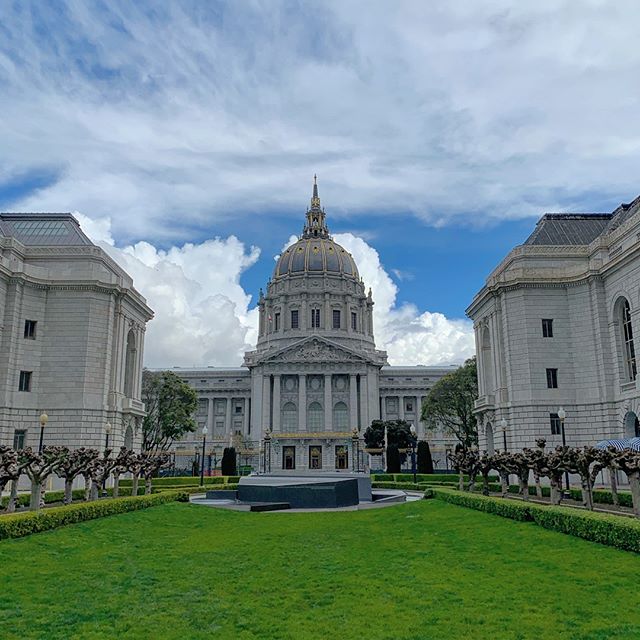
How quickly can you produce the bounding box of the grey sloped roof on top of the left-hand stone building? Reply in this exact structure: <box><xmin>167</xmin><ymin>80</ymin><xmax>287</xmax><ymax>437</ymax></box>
<box><xmin>0</xmin><ymin>212</ymin><xmax>93</xmax><ymax>246</ymax></box>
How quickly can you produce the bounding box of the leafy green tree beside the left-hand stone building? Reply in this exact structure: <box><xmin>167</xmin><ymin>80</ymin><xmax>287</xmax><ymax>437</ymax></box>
<box><xmin>142</xmin><ymin>369</ymin><xmax>198</xmax><ymax>453</ymax></box>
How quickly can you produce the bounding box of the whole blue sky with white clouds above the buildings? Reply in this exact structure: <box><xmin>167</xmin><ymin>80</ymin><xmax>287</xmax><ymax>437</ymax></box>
<box><xmin>0</xmin><ymin>0</ymin><xmax>640</xmax><ymax>365</ymax></box>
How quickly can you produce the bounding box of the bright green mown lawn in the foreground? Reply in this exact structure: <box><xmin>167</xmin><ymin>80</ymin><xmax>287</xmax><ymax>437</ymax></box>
<box><xmin>0</xmin><ymin>500</ymin><xmax>640</xmax><ymax>640</ymax></box>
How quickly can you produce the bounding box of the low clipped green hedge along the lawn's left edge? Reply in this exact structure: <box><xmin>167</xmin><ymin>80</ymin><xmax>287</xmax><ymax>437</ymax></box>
<box><xmin>0</xmin><ymin>491</ymin><xmax>189</xmax><ymax>540</ymax></box>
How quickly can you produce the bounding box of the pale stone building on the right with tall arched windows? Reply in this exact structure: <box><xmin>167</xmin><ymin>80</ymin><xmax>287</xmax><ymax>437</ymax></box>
<box><xmin>467</xmin><ymin>198</ymin><xmax>640</xmax><ymax>450</ymax></box>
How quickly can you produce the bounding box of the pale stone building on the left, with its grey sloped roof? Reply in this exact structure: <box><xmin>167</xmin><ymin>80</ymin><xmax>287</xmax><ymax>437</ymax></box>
<box><xmin>0</xmin><ymin>213</ymin><xmax>153</xmax><ymax>447</ymax></box>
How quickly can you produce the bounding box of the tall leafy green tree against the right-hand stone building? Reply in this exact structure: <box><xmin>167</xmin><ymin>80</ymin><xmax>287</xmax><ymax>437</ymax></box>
<box><xmin>421</xmin><ymin>357</ymin><xmax>478</xmax><ymax>449</ymax></box>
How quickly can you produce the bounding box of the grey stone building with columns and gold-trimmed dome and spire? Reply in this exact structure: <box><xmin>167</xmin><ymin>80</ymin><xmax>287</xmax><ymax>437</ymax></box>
<box><xmin>174</xmin><ymin>184</ymin><xmax>453</xmax><ymax>470</ymax></box>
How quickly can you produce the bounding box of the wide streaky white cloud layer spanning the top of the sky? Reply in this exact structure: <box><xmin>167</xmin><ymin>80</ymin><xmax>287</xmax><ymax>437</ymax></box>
<box><xmin>0</xmin><ymin>0</ymin><xmax>640</xmax><ymax>243</ymax></box>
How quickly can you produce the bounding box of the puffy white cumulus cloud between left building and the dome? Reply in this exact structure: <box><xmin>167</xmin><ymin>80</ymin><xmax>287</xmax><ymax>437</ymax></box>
<box><xmin>75</xmin><ymin>212</ymin><xmax>260</xmax><ymax>367</ymax></box>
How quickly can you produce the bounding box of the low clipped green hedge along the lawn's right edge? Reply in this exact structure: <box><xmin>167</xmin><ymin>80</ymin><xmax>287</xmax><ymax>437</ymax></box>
<box><xmin>431</xmin><ymin>488</ymin><xmax>640</xmax><ymax>553</ymax></box>
